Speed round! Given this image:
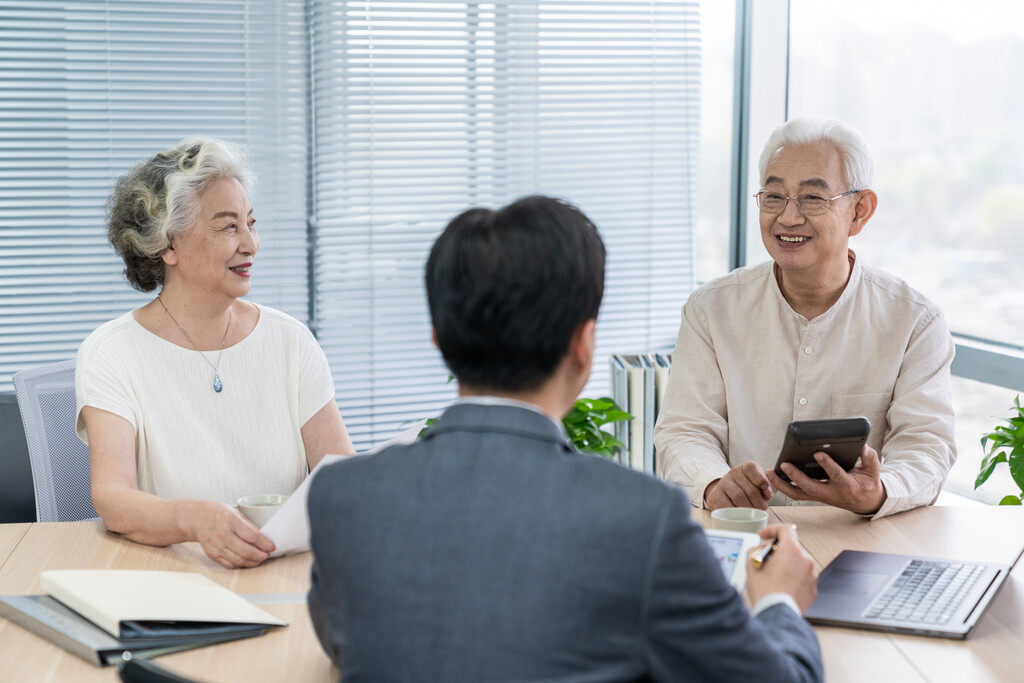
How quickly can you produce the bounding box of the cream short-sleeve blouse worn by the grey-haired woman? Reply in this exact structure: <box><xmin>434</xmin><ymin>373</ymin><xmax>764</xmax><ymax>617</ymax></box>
<box><xmin>75</xmin><ymin>306</ymin><xmax>335</xmax><ymax>503</ymax></box>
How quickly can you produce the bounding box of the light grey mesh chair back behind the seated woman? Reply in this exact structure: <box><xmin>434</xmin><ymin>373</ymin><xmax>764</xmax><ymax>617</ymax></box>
<box><xmin>13</xmin><ymin>359</ymin><xmax>97</xmax><ymax>522</ymax></box>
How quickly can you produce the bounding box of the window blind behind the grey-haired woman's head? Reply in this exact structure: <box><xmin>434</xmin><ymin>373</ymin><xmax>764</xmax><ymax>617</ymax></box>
<box><xmin>0</xmin><ymin>0</ymin><xmax>308</xmax><ymax>391</ymax></box>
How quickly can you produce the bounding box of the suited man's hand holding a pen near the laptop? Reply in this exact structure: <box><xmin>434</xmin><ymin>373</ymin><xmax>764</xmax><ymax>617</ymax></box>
<box><xmin>746</xmin><ymin>526</ymin><xmax>818</xmax><ymax>614</ymax></box>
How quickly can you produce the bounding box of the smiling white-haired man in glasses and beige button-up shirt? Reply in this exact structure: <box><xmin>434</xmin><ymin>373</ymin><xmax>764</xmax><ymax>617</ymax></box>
<box><xmin>654</xmin><ymin>119</ymin><xmax>956</xmax><ymax>518</ymax></box>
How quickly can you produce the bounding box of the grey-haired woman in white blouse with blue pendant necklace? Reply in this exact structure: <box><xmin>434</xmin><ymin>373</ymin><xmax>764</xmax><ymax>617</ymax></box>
<box><xmin>76</xmin><ymin>138</ymin><xmax>354</xmax><ymax>567</ymax></box>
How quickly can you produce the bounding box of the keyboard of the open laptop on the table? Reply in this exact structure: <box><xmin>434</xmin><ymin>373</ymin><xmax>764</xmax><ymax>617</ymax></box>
<box><xmin>864</xmin><ymin>560</ymin><xmax>985</xmax><ymax>624</ymax></box>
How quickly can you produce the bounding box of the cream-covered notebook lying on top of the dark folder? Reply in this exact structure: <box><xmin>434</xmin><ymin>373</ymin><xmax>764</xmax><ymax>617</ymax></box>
<box><xmin>39</xmin><ymin>569</ymin><xmax>288</xmax><ymax>638</ymax></box>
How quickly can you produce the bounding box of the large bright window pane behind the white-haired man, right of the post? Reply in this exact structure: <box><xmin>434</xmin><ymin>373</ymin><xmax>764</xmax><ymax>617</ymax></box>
<box><xmin>788</xmin><ymin>0</ymin><xmax>1024</xmax><ymax>345</ymax></box>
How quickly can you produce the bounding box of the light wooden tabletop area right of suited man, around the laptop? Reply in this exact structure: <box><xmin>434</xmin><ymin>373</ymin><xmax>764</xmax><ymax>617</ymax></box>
<box><xmin>695</xmin><ymin>506</ymin><xmax>1024</xmax><ymax>683</ymax></box>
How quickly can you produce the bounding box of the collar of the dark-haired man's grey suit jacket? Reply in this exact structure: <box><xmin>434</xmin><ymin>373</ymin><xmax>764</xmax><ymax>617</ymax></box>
<box><xmin>424</xmin><ymin>400</ymin><xmax>574</xmax><ymax>453</ymax></box>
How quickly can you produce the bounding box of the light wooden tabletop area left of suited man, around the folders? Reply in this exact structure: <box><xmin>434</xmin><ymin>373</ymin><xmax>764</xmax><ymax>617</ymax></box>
<box><xmin>0</xmin><ymin>522</ymin><xmax>338</xmax><ymax>683</ymax></box>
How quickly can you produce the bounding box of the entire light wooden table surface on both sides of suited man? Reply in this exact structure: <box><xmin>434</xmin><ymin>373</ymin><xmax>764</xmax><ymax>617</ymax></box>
<box><xmin>6</xmin><ymin>507</ymin><xmax>1024</xmax><ymax>683</ymax></box>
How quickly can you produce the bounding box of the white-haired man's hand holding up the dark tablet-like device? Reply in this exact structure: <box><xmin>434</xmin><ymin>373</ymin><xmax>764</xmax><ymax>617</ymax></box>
<box><xmin>768</xmin><ymin>445</ymin><xmax>886</xmax><ymax>514</ymax></box>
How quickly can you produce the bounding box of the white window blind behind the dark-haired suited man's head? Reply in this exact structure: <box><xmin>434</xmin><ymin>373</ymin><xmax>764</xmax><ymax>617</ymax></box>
<box><xmin>311</xmin><ymin>0</ymin><xmax>699</xmax><ymax>449</ymax></box>
